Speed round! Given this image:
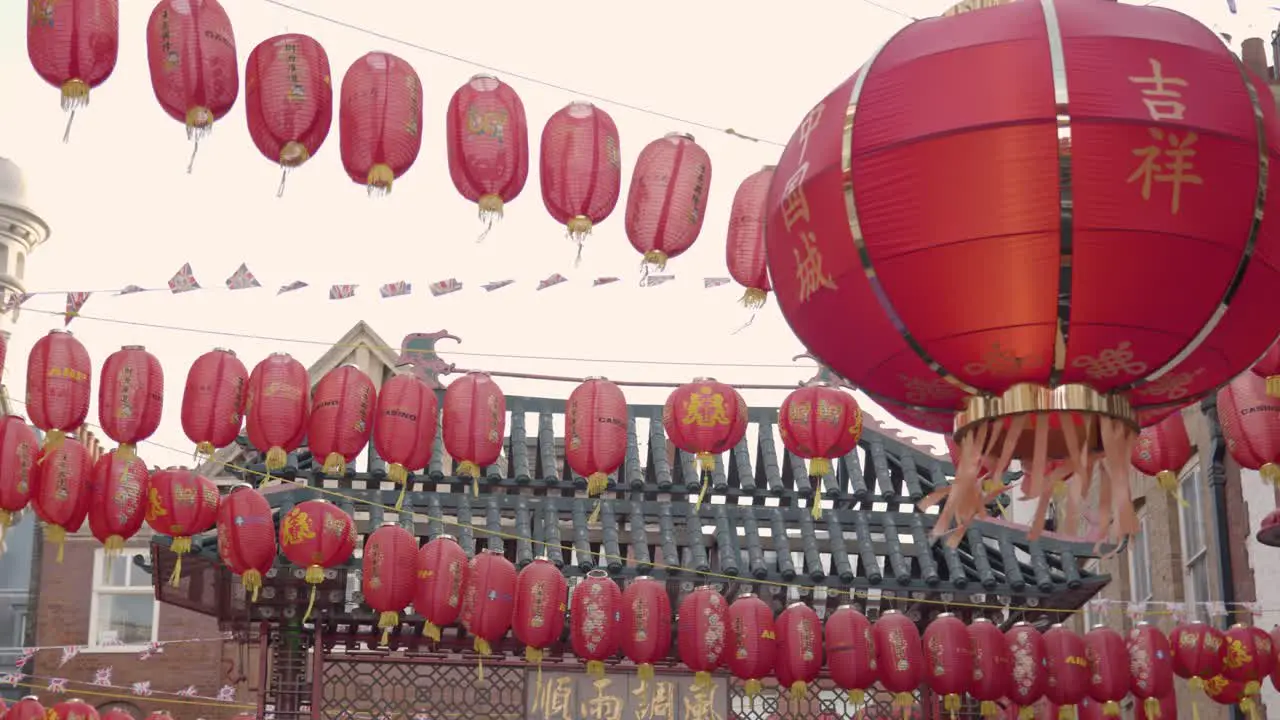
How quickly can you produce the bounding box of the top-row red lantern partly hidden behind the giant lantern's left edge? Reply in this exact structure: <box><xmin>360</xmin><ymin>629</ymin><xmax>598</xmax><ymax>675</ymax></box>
<box><xmin>724</xmin><ymin>165</ymin><xmax>774</xmax><ymax>307</ymax></box>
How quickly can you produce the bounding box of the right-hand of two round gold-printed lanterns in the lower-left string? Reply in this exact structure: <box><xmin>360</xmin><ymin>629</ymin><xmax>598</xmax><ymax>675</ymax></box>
<box><xmin>280</xmin><ymin>500</ymin><xmax>356</xmax><ymax>623</ymax></box>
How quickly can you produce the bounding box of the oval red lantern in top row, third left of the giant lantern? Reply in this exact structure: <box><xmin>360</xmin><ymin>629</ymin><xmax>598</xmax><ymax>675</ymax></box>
<box><xmin>538</xmin><ymin>102</ymin><xmax>622</xmax><ymax>258</ymax></box>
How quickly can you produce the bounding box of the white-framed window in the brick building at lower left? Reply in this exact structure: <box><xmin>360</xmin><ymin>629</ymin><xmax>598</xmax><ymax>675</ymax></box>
<box><xmin>88</xmin><ymin>548</ymin><xmax>160</xmax><ymax>651</ymax></box>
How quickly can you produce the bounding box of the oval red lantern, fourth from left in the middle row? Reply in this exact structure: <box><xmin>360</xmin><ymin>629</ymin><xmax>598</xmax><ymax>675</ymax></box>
<box><xmin>244</xmin><ymin>352</ymin><xmax>311</xmax><ymax>471</ymax></box>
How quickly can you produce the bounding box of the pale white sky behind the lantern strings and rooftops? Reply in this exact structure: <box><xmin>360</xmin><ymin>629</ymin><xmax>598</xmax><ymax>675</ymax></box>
<box><xmin>0</xmin><ymin>0</ymin><xmax>1280</xmax><ymax>465</ymax></box>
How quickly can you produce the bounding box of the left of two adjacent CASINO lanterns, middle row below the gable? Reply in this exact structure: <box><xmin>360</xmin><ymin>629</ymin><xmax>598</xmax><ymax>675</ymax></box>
<box><xmin>307</xmin><ymin>365</ymin><xmax>378</xmax><ymax>475</ymax></box>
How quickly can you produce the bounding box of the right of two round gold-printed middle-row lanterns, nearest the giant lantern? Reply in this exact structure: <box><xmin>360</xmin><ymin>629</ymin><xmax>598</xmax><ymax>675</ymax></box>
<box><xmin>778</xmin><ymin>382</ymin><xmax>863</xmax><ymax>520</ymax></box>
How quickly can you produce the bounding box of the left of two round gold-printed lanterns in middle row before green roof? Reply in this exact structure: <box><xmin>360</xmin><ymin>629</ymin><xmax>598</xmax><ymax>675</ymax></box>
<box><xmin>662</xmin><ymin>378</ymin><xmax>748</xmax><ymax>510</ymax></box>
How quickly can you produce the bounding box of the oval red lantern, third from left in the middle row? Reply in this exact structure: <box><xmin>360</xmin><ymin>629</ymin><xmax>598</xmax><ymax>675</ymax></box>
<box><xmin>182</xmin><ymin>347</ymin><xmax>248</xmax><ymax>457</ymax></box>
